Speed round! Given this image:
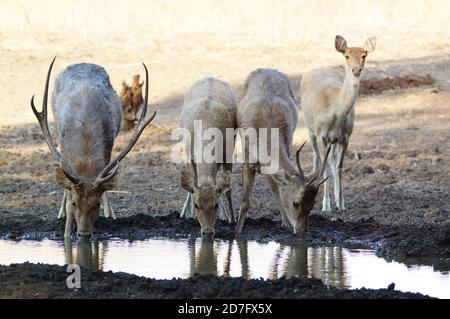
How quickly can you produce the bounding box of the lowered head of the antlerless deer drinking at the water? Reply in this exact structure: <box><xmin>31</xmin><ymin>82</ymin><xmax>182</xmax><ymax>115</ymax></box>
<box><xmin>180</xmin><ymin>169</ymin><xmax>231</xmax><ymax>236</ymax></box>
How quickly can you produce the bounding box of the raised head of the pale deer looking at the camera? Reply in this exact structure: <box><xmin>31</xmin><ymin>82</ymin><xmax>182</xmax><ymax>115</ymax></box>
<box><xmin>335</xmin><ymin>35</ymin><xmax>377</xmax><ymax>78</ymax></box>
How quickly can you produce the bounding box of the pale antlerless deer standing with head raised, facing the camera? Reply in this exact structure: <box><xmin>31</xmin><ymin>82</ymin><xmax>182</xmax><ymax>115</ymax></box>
<box><xmin>301</xmin><ymin>35</ymin><xmax>376</xmax><ymax>211</ymax></box>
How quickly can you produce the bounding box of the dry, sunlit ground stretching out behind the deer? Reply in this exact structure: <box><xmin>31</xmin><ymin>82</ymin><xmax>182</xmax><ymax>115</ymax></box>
<box><xmin>0</xmin><ymin>0</ymin><xmax>450</xmax><ymax>248</ymax></box>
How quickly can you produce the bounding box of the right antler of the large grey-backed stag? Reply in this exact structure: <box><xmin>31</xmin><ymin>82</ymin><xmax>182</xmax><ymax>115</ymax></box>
<box><xmin>94</xmin><ymin>63</ymin><xmax>156</xmax><ymax>186</ymax></box>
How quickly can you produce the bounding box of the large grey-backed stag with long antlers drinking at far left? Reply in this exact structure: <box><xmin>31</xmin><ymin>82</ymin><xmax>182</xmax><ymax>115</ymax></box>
<box><xmin>31</xmin><ymin>58</ymin><xmax>156</xmax><ymax>237</ymax></box>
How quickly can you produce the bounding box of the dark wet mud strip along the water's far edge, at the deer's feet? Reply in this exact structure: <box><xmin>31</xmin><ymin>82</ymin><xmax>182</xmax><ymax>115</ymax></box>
<box><xmin>0</xmin><ymin>213</ymin><xmax>450</xmax><ymax>261</ymax></box>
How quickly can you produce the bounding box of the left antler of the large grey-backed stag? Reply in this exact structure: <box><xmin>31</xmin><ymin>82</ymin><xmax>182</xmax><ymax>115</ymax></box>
<box><xmin>31</xmin><ymin>56</ymin><xmax>80</xmax><ymax>184</ymax></box>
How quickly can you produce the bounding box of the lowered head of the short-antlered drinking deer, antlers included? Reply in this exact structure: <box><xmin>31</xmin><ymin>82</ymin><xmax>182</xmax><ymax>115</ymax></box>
<box><xmin>274</xmin><ymin>142</ymin><xmax>330</xmax><ymax>233</ymax></box>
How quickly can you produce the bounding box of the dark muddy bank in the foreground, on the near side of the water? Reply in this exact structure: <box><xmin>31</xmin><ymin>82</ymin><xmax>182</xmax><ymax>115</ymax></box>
<box><xmin>0</xmin><ymin>263</ymin><xmax>427</xmax><ymax>299</ymax></box>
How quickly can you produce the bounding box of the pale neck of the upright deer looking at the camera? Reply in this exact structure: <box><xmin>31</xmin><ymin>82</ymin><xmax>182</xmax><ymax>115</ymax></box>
<box><xmin>336</xmin><ymin>71</ymin><xmax>360</xmax><ymax>118</ymax></box>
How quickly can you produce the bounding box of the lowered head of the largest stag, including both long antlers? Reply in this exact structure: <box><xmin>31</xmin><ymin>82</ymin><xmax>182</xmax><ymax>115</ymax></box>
<box><xmin>31</xmin><ymin>57</ymin><xmax>156</xmax><ymax>237</ymax></box>
